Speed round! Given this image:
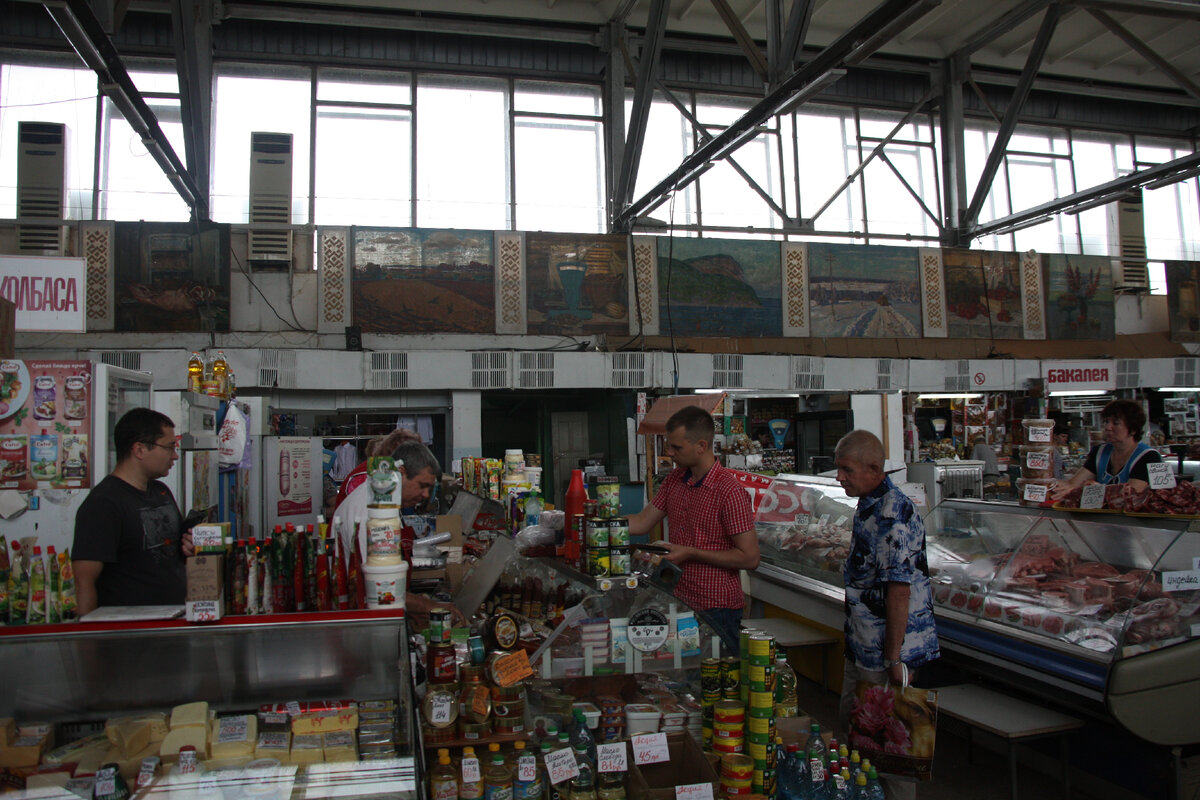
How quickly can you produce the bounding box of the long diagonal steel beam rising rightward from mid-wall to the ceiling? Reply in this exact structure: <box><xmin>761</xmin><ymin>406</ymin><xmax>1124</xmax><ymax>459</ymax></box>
<box><xmin>613</xmin><ymin>0</ymin><xmax>941</xmax><ymax>231</ymax></box>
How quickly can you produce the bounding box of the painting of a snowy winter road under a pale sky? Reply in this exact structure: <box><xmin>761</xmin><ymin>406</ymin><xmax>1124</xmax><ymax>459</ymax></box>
<box><xmin>809</xmin><ymin>242</ymin><xmax>922</xmax><ymax>338</ymax></box>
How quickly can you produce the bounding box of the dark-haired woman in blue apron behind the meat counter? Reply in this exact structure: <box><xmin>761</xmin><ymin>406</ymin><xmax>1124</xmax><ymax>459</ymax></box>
<box><xmin>1050</xmin><ymin>401</ymin><xmax>1163</xmax><ymax>500</ymax></box>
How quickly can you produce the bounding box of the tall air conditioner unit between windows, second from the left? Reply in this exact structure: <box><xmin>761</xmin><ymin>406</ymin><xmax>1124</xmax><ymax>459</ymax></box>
<box><xmin>250</xmin><ymin>132</ymin><xmax>292</xmax><ymax>267</ymax></box>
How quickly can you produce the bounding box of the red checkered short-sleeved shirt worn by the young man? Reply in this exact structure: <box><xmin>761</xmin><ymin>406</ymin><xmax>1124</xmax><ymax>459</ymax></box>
<box><xmin>652</xmin><ymin>464</ymin><xmax>755</xmax><ymax>610</ymax></box>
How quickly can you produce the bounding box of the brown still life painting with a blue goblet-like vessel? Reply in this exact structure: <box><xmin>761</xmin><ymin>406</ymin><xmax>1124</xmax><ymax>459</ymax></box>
<box><xmin>524</xmin><ymin>233</ymin><xmax>630</xmax><ymax>336</ymax></box>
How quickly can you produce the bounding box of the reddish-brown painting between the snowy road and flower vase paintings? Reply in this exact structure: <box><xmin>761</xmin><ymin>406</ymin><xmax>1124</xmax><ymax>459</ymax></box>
<box><xmin>942</xmin><ymin>249</ymin><xmax>1025</xmax><ymax>339</ymax></box>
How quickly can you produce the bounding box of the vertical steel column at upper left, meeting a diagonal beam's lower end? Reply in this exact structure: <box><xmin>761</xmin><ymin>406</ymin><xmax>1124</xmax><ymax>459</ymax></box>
<box><xmin>170</xmin><ymin>0</ymin><xmax>212</xmax><ymax>215</ymax></box>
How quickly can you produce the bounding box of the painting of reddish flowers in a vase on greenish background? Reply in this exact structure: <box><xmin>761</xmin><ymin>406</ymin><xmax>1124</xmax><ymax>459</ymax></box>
<box><xmin>1045</xmin><ymin>254</ymin><xmax>1116</xmax><ymax>339</ymax></box>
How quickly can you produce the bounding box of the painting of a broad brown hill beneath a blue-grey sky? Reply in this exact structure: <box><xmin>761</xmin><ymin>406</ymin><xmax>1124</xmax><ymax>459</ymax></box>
<box><xmin>350</xmin><ymin>228</ymin><xmax>496</xmax><ymax>333</ymax></box>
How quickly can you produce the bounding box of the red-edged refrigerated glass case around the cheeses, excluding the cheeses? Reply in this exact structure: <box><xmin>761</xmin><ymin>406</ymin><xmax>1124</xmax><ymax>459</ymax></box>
<box><xmin>0</xmin><ymin>610</ymin><xmax>420</xmax><ymax>799</ymax></box>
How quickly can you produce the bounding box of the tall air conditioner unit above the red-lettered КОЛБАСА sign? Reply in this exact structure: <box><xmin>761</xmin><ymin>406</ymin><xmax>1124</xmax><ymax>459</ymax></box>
<box><xmin>17</xmin><ymin>122</ymin><xmax>67</xmax><ymax>255</ymax></box>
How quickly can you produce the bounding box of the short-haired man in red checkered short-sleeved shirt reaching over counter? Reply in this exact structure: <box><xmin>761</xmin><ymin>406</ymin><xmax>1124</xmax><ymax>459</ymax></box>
<box><xmin>629</xmin><ymin>405</ymin><xmax>758</xmax><ymax>652</ymax></box>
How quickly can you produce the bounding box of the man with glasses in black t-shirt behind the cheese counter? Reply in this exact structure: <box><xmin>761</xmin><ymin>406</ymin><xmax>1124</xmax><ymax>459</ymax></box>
<box><xmin>72</xmin><ymin>408</ymin><xmax>192</xmax><ymax>616</ymax></box>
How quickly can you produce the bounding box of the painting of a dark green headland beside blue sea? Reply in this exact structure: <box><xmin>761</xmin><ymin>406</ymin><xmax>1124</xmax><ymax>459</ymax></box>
<box><xmin>658</xmin><ymin>237</ymin><xmax>782</xmax><ymax>336</ymax></box>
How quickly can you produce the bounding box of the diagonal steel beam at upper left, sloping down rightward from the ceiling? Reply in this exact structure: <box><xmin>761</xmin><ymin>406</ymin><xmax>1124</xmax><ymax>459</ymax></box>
<box><xmin>42</xmin><ymin>0</ymin><xmax>209</xmax><ymax>219</ymax></box>
